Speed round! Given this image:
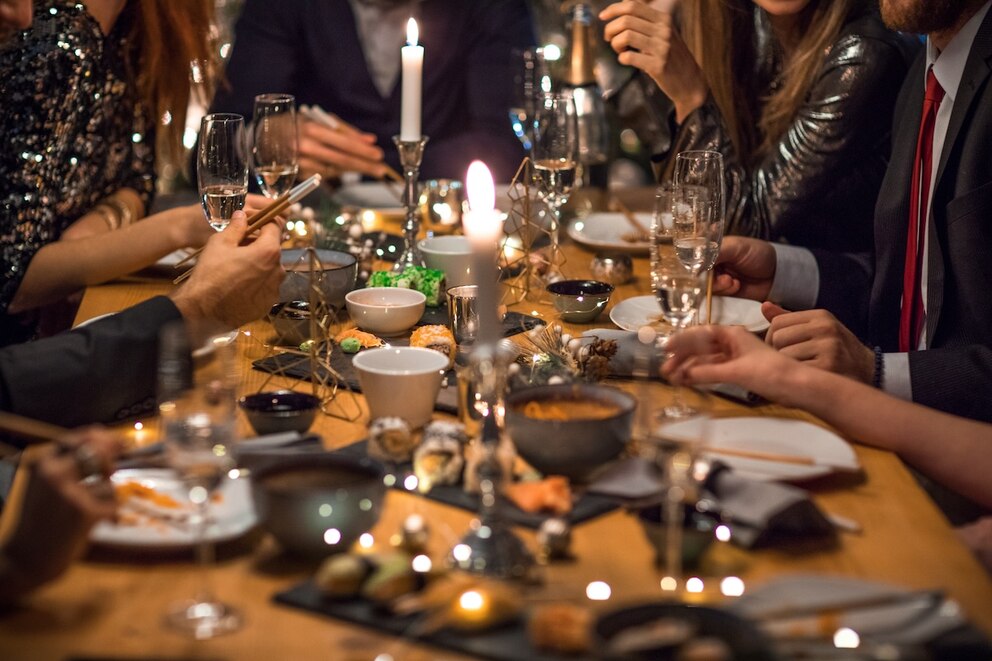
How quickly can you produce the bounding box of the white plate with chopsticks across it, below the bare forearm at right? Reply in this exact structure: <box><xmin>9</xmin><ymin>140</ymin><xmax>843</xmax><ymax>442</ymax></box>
<box><xmin>662</xmin><ymin>418</ymin><xmax>860</xmax><ymax>482</ymax></box>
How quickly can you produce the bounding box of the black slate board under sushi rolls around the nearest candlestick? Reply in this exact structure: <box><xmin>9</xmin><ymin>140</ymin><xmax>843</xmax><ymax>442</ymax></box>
<box><xmin>334</xmin><ymin>441</ymin><xmax>619</xmax><ymax>529</ymax></box>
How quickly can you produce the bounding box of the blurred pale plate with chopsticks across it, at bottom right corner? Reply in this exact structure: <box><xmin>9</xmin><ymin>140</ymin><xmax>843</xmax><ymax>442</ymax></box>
<box><xmin>732</xmin><ymin>575</ymin><xmax>964</xmax><ymax>644</ymax></box>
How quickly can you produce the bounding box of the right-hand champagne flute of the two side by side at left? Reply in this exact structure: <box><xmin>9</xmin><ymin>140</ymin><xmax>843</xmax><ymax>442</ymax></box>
<box><xmin>251</xmin><ymin>94</ymin><xmax>300</xmax><ymax>199</ymax></box>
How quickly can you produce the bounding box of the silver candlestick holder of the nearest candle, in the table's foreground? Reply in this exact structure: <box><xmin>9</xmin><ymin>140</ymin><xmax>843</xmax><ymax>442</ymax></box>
<box><xmin>448</xmin><ymin>345</ymin><xmax>534</xmax><ymax>580</ymax></box>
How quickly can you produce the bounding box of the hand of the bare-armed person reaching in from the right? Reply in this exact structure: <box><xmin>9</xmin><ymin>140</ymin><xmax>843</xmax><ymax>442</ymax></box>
<box><xmin>662</xmin><ymin>326</ymin><xmax>805</xmax><ymax>406</ymax></box>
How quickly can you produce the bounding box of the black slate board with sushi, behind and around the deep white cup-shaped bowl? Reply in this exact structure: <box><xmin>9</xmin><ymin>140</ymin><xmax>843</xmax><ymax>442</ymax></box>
<box><xmin>252</xmin><ymin>307</ymin><xmax>544</xmax><ymax>415</ymax></box>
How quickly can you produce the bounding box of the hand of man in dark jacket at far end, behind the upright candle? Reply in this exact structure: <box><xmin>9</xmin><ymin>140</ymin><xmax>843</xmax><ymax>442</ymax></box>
<box><xmin>300</xmin><ymin>119</ymin><xmax>386</xmax><ymax>179</ymax></box>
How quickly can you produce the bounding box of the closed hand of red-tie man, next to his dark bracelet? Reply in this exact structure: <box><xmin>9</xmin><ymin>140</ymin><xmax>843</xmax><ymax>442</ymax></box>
<box><xmin>761</xmin><ymin>302</ymin><xmax>875</xmax><ymax>384</ymax></box>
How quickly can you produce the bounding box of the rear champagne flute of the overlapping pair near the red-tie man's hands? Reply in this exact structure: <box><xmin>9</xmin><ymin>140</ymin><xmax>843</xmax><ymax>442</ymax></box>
<box><xmin>672</xmin><ymin>151</ymin><xmax>726</xmax><ymax>322</ymax></box>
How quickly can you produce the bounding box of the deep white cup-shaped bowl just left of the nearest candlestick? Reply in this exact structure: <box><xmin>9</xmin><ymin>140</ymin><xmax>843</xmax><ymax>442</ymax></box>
<box><xmin>352</xmin><ymin>347</ymin><xmax>448</xmax><ymax>429</ymax></box>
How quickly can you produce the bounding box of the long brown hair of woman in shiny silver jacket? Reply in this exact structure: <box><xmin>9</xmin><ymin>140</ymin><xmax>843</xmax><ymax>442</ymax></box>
<box><xmin>680</xmin><ymin>0</ymin><xmax>868</xmax><ymax>162</ymax></box>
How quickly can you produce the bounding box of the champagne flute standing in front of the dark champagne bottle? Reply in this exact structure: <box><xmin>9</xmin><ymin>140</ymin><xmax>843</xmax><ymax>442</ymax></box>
<box><xmin>532</xmin><ymin>93</ymin><xmax>579</xmax><ymax>282</ymax></box>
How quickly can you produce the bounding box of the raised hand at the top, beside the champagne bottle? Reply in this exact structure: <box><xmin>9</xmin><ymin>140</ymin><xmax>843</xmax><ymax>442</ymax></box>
<box><xmin>599</xmin><ymin>0</ymin><xmax>709</xmax><ymax>123</ymax></box>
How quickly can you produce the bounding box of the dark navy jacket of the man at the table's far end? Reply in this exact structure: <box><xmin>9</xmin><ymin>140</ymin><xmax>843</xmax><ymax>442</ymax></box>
<box><xmin>212</xmin><ymin>0</ymin><xmax>535</xmax><ymax>181</ymax></box>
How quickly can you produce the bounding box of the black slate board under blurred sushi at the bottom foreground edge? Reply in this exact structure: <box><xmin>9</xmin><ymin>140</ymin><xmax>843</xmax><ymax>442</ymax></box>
<box><xmin>273</xmin><ymin>581</ymin><xmax>592</xmax><ymax>661</ymax></box>
